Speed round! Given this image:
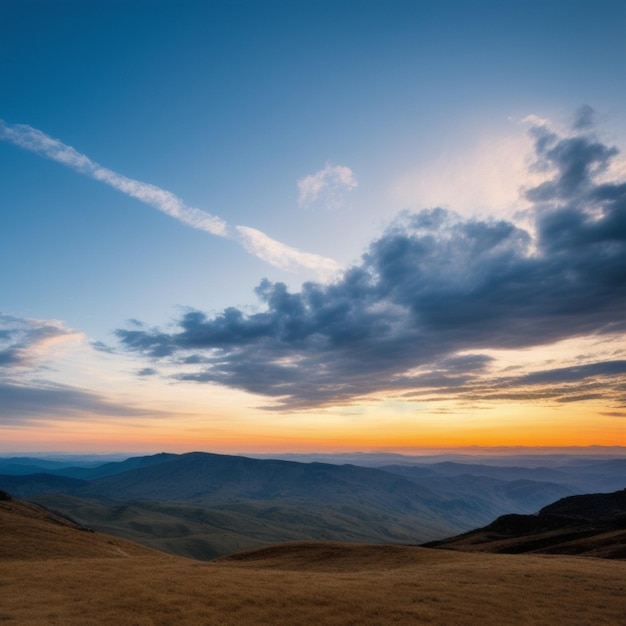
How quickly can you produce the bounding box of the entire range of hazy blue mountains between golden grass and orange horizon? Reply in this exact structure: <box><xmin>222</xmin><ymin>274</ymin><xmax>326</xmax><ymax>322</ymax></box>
<box><xmin>0</xmin><ymin>452</ymin><xmax>626</xmax><ymax>559</ymax></box>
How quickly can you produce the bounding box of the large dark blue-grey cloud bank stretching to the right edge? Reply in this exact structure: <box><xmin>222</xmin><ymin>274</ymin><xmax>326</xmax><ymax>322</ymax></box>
<box><xmin>116</xmin><ymin>114</ymin><xmax>626</xmax><ymax>409</ymax></box>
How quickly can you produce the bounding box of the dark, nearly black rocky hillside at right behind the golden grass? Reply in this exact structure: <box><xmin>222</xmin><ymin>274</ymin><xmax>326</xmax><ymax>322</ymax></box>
<box><xmin>424</xmin><ymin>489</ymin><xmax>626</xmax><ymax>559</ymax></box>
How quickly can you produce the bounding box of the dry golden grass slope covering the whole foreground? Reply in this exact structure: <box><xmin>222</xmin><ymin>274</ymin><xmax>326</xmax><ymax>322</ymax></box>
<box><xmin>0</xmin><ymin>494</ymin><xmax>626</xmax><ymax>626</ymax></box>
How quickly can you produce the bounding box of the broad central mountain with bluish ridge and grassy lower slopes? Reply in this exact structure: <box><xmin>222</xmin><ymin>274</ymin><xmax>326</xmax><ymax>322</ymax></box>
<box><xmin>25</xmin><ymin>453</ymin><xmax>464</xmax><ymax>559</ymax></box>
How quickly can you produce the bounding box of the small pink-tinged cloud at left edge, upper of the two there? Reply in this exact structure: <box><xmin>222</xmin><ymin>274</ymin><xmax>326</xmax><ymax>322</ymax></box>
<box><xmin>0</xmin><ymin>313</ymin><xmax>83</xmax><ymax>368</ymax></box>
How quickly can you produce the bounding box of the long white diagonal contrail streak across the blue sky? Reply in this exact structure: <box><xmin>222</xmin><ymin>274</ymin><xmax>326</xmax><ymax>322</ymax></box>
<box><xmin>0</xmin><ymin>119</ymin><xmax>341</xmax><ymax>279</ymax></box>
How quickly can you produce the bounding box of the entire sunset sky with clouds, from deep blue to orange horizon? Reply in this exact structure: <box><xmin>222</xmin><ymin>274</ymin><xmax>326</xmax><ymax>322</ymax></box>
<box><xmin>0</xmin><ymin>0</ymin><xmax>626</xmax><ymax>454</ymax></box>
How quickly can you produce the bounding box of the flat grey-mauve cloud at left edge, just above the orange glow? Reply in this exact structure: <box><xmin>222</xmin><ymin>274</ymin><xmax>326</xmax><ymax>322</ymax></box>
<box><xmin>0</xmin><ymin>382</ymin><xmax>163</xmax><ymax>425</ymax></box>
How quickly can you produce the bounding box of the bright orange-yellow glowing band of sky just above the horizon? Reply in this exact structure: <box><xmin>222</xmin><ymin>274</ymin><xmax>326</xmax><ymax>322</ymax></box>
<box><xmin>0</xmin><ymin>406</ymin><xmax>626</xmax><ymax>454</ymax></box>
